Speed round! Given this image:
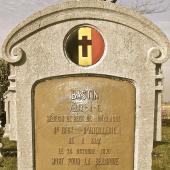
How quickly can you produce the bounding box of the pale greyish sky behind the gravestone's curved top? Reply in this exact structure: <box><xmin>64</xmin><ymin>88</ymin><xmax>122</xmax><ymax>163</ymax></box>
<box><xmin>0</xmin><ymin>0</ymin><xmax>170</xmax><ymax>102</ymax></box>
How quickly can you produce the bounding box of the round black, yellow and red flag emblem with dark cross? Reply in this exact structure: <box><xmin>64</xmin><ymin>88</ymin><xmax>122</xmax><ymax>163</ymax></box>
<box><xmin>66</xmin><ymin>27</ymin><xmax>105</xmax><ymax>66</ymax></box>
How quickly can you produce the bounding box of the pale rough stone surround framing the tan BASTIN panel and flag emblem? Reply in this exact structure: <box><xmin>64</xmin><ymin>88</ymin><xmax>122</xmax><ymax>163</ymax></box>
<box><xmin>2</xmin><ymin>0</ymin><xmax>170</xmax><ymax>170</ymax></box>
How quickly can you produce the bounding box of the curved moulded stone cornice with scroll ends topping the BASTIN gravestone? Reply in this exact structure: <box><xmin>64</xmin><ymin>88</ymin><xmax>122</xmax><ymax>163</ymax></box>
<box><xmin>2</xmin><ymin>0</ymin><xmax>170</xmax><ymax>63</ymax></box>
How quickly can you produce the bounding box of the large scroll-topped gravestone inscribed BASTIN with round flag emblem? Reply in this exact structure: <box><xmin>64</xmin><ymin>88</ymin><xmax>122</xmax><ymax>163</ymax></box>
<box><xmin>2</xmin><ymin>0</ymin><xmax>170</xmax><ymax>170</ymax></box>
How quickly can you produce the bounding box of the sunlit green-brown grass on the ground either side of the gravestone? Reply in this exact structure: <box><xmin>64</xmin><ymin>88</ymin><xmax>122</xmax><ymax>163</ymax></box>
<box><xmin>0</xmin><ymin>127</ymin><xmax>170</xmax><ymax>170</ymax></box>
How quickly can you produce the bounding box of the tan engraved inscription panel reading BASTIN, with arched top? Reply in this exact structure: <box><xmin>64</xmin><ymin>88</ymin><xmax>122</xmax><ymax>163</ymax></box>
<box><xmin>34</xmin><ymin>76</ymin><xmax>136</xmax><ymax>170</ymax></box>
